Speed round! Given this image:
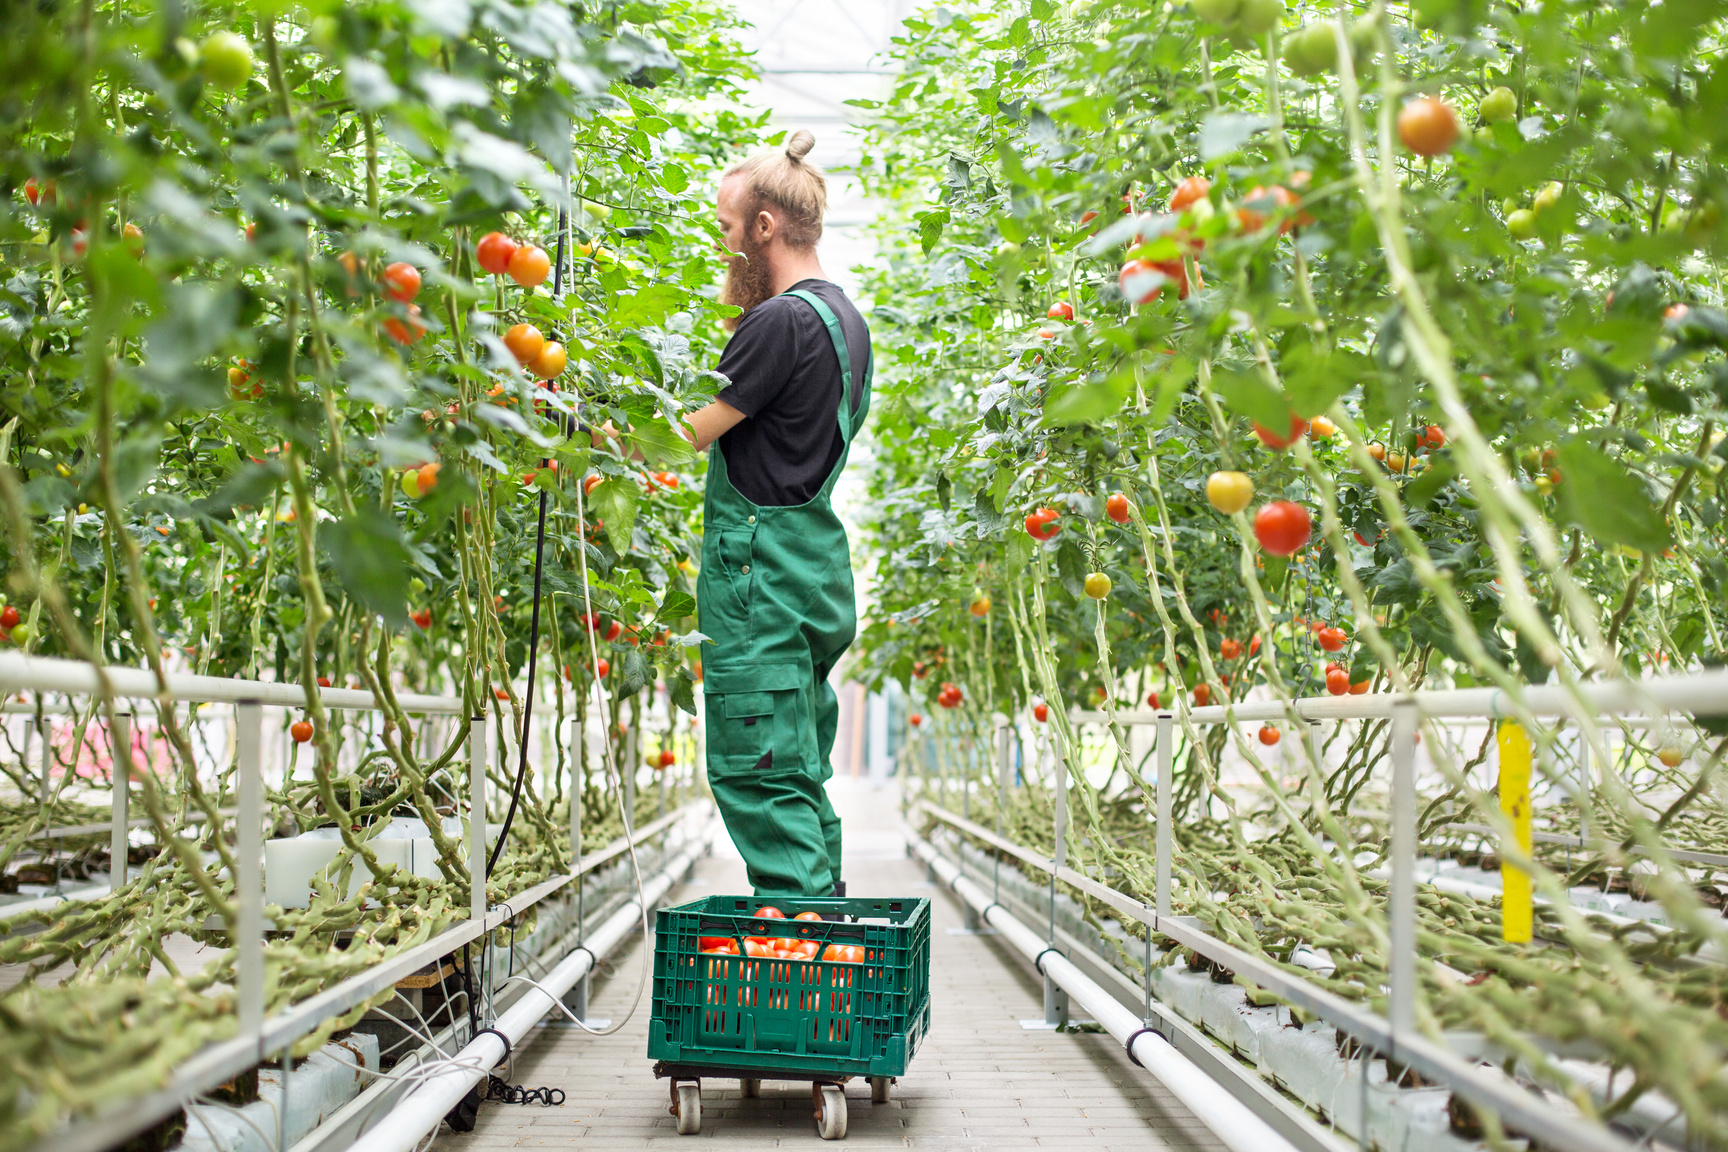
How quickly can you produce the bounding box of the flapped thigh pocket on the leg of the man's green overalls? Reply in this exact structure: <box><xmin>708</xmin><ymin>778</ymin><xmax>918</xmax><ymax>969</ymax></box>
<box><xmin>703</xmin><ymin>663</ymin><xmax>807</xmax><ymax>777</ymax></box>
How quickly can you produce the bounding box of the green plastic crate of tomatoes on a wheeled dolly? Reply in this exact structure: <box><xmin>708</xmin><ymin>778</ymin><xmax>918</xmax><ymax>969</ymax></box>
<box><xmin>648</xmin><ymin>896</ymin><xmax>930</xmax><ymax>1076</ymax></box>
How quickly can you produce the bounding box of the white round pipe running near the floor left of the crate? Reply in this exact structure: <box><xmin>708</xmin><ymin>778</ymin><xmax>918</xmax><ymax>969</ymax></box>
<box><xmin>349</xmin><ymin>824</ymin><xmax>714</xmax><ymax>1152</ymax></box>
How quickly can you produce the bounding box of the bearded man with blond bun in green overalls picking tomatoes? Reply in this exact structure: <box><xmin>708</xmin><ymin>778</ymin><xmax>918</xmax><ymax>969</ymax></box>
<box><xmin>673</xmin><ymin>131</ymin><xmax>871</xmax><ymax>896</ymax></box>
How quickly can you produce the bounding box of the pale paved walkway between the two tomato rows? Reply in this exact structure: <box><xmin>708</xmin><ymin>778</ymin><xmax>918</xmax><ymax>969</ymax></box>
<box><xmin>434</xmin><ymin>779</ymin><xmax>1223</xmax><ymax>1152</ymax></box>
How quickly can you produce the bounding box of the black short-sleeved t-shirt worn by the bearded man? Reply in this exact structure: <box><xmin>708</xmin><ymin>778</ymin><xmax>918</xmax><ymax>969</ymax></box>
<box><xmin>719</xmin><ymin>280</ymin><xmax>869</xmax><ymax>506</ymax></box>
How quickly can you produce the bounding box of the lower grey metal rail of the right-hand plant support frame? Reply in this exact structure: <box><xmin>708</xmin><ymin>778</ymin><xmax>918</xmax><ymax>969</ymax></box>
<box><xmin>912</xmin><ymin>801</ymin><xmax>1640</xmax><ymax>1152</ymax></box>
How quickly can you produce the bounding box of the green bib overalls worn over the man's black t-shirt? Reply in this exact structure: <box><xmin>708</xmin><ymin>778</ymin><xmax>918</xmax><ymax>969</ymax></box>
<box><xmin>696</xmin><ymin>292</ymin><xmax>874</xmax><ymax>896</ymax></box>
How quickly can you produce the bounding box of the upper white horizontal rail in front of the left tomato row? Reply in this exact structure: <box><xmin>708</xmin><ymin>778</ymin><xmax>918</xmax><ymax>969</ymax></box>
<box><xmin>0</xmin><ymin>653</ymin><xmax>461</xmax><ymax>715</ymax></box>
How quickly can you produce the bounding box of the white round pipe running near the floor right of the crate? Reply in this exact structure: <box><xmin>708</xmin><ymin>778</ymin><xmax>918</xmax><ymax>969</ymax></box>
<box><xmin>912</xmin><ymin>832</ymin><xmax>1296</xmax><ymax>1152</ymax></box>
